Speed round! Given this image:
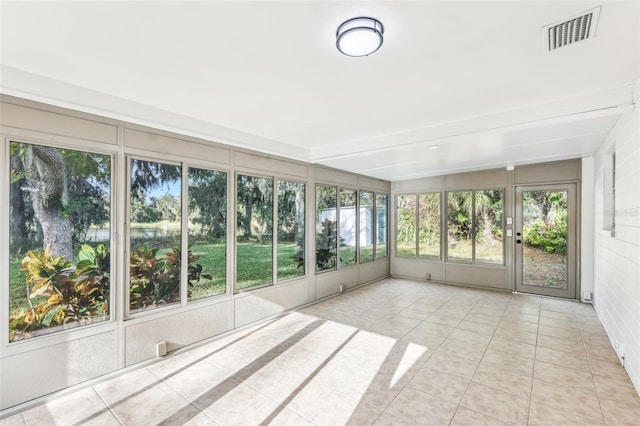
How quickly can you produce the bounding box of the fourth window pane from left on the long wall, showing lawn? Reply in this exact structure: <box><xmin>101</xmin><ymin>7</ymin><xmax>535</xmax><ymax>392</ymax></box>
<box><xmin>236</xmin><ymin>175</ymin><xmax>273</xmax><ymax>290</ymax></box>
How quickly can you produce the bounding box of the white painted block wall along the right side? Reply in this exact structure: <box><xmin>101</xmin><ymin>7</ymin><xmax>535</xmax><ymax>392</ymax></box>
<box><xmin>593</xmin><ymin>82</ymin><xmax>640</xmax><ymax>391</ymax></box>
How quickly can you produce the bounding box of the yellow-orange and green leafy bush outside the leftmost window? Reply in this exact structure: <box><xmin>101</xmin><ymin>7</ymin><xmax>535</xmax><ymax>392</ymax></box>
<box><xmin>9</xmin><ymin>244</ymin><xmax>110</xmax><ymax>341</ymax></box>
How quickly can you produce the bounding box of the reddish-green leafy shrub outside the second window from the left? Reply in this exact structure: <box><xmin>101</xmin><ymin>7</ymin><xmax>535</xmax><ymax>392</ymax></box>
<box><xmin>129</xmin><ymin>245</ymin><xmax>213</xmax><ymax>309</ymax></box>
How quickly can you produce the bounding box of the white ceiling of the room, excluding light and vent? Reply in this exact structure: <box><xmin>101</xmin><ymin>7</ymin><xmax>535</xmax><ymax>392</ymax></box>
<box><xmin>0</xmin><ymin>1</ymin><xmax>640</xmax><ymax>181</ymax></box>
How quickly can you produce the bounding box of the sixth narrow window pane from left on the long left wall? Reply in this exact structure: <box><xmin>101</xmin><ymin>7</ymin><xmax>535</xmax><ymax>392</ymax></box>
<box><xmin>316</xmin><ymin>185</ymin><xmax>338</xmax><ymax>272</ymax></box>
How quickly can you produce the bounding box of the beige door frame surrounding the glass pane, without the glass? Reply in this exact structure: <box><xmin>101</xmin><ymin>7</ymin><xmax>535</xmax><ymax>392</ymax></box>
<box><xmin>513</xmin><ymin>182</ymin><xmax>580</xmax><ymax>300</ymax></box>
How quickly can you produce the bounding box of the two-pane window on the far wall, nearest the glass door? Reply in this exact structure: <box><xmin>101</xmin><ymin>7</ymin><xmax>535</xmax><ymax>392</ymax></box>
<box><xmin>447</xmin><ymin>189</ymin><xmax>504</xmax><ymax>264</ymax></box>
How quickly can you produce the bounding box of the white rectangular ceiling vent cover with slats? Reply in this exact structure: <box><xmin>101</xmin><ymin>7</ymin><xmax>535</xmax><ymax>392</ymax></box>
<box><xmin>543</xmin><ymin>6</ymin><xmax>601</xmax><ymax>51</ymax></box>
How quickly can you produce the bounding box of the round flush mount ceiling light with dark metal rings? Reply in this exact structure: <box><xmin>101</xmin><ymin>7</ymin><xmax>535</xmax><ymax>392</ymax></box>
<box><xmin>336</xmin><ymin>17</ymin><xmax>384</xmax><ymax>56</ymax></box>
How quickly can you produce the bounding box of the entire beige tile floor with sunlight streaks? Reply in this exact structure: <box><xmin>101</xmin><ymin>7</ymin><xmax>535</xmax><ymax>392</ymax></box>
<box><xmin>2</xmin><ymin>279</ymin><xmax>640</xmax><ymax>426</ymax></box>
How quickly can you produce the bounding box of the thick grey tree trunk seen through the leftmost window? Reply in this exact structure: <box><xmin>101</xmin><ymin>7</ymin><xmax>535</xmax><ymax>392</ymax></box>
<box><xmin>25</xmin><ymin>145</ymin><xmax>73</xmax><ymax>261</ymax></box>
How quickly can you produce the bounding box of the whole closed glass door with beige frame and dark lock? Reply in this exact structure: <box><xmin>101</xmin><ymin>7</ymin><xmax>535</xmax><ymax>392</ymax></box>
<box><xmin>515</xmin><ymin>184</ymin><xmax>577</xmax><ymax>299</ymax></box>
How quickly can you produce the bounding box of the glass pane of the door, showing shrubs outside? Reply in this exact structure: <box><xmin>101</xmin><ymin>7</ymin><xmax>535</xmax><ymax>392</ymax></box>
<box><xmin>522</xmin><ymin>190</ymin><xmax>569</xmax><ymax>290</ymax></box>
